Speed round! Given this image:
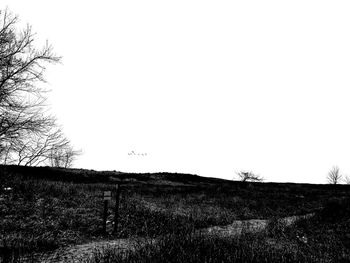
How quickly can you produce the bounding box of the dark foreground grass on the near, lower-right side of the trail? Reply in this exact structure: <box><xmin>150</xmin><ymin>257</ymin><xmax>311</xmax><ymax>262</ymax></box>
<box><xmin>86</xmin><ymin>201</ymin><xmax>350</xmax><ymax>263</ymax></box>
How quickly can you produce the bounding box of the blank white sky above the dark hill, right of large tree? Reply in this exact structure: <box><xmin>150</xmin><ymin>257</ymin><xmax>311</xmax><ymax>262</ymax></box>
<box><xmin>4</xmin><ymin>0</ymin><xmax>350</xmax><ymax>183</ymax></box>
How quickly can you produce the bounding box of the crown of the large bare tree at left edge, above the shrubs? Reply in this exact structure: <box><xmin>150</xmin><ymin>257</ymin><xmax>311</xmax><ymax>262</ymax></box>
<box><xmin>0</xmin><ymin>10</ymin><xmax>60</xmax><ymax>161</ymax></box>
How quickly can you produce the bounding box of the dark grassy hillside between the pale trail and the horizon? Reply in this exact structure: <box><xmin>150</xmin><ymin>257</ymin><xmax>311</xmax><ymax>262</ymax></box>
<box><xmin>0</xmin><ymin>166</ymin><xmax>350</xmax><ymax>258</ymax></box>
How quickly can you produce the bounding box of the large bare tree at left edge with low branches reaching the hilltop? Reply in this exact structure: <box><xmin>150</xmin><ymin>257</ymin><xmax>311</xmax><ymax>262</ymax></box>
<box><xmin>0</xmin><ymin>10</ymin><xmax>78</xmax><ymax>166</ymax></box>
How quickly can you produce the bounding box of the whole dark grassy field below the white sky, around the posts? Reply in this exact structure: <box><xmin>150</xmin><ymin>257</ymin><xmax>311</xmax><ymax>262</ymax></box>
<box><xmin>0</xmin><ymin>166</ymin><xmax>350</xmax><ymax>262</ymax></box>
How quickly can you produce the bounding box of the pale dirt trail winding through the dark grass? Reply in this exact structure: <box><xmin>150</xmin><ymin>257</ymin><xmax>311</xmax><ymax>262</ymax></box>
<box><xmin>27</xmin><ymin>214</ymin><xmax>313</xmax><ymax>263</ymax></box>
